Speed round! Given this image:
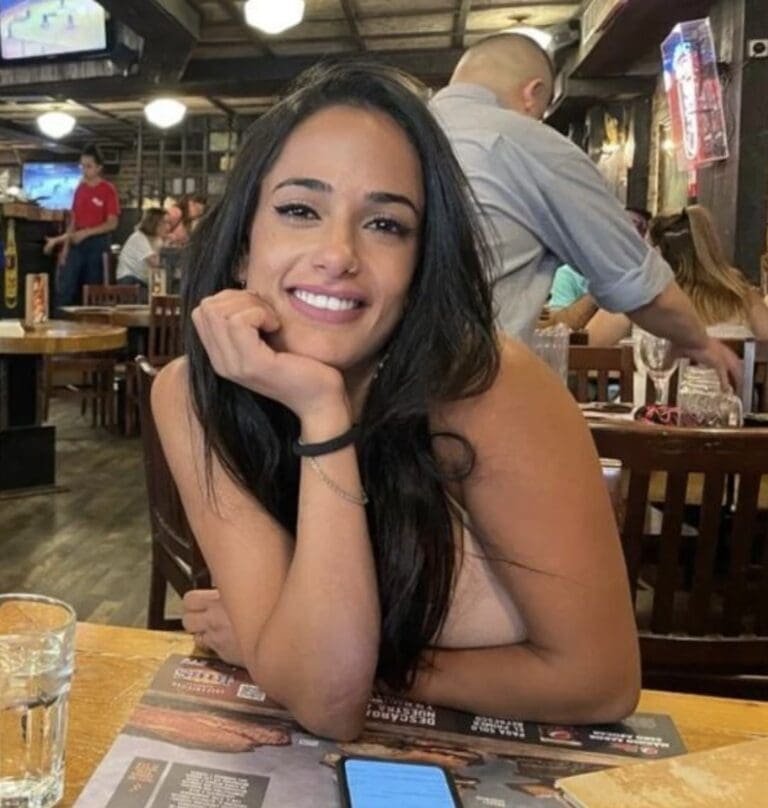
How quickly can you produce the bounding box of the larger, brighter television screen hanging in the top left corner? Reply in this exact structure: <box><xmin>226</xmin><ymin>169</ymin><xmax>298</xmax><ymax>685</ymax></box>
<box><xmin>0</xmin><ymin>0</ymin><xmax>107</xmax><ymax>59</ymax></box>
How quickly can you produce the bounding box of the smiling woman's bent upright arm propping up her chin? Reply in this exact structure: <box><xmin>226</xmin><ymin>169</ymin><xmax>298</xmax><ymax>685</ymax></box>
<box><xmin>153</xmin><ymin>292</ymin><xmax>379</xmax><ymax>738</ymax></box>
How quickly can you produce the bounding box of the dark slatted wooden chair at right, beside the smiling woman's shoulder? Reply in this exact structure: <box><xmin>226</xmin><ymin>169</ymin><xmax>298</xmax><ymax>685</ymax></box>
<box><xmin>590</xmin><ymin>423</ymin><xmax>768</xmax><ymax>698</ymax></box>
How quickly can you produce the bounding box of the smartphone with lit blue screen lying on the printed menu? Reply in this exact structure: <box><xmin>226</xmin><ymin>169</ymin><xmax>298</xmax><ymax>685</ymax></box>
<box><xmin>338</xmin><ymin>756</ymin><xmax>461</xmax><ymax>808</ymax></box>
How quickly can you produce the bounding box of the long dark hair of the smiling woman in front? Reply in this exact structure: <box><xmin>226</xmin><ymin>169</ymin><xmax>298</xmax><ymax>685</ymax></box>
<box><xmin>184</xmin><ymin>63</ymin><xmax>499</xmax><ymax>689</ymax></box>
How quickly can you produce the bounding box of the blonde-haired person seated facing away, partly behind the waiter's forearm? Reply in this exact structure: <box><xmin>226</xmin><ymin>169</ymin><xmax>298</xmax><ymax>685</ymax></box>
<box><xmin>587</xmin><ymin>205</ymin><xmax>768</xmax><ymax>345</ymax></box>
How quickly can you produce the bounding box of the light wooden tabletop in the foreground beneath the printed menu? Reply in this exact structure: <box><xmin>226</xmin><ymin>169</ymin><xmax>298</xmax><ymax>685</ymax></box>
<box><xmin>61</xmin><ymin>623</ymin><xmax>768</xmax><ymax>808</ymax></box>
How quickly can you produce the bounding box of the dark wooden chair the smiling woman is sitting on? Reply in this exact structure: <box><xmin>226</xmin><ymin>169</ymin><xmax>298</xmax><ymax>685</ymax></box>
<box><xmin>136</xmin><ymin>356</ymin><xmax>211</xmax><ymax>630</ymax></box>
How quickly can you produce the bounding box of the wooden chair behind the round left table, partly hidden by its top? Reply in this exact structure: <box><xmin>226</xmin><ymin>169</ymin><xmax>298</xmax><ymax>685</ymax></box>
<box><xmin>45</xmin><ymin>284</ymin><xmax>141</xmax><ymax>427</ymax></box>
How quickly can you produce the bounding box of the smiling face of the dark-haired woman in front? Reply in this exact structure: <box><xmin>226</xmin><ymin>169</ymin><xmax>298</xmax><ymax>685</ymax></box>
<box><xmin>244</xmin><ymin>106</ymin><xmax>424</xmax><ymax>371</ymax></box>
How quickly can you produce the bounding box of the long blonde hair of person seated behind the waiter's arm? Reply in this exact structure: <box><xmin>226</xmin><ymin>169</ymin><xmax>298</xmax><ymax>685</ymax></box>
<box><xmin>648</xmin><ymin>205</ymin><xmax>751</xmax><ymax>325</ymax></box>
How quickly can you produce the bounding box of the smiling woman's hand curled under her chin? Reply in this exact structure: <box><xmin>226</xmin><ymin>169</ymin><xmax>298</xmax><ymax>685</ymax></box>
<box><xmin>192</xmin><ymin>289</ymin><xmax>347</xmax><ymax>420</ymax></box>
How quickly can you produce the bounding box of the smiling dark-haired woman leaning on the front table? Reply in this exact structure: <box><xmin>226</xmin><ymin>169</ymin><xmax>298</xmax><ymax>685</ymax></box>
<box><xmin>153</xmin><ymin>65</ymin><xmax>639</xmax><ymax>738</ymax></box>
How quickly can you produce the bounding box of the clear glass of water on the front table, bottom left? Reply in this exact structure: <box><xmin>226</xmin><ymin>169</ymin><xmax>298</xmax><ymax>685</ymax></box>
<box><xmin>0</xmin><ymin>594</ymin><xmax>75</xmax><ymax>808</ymax></box>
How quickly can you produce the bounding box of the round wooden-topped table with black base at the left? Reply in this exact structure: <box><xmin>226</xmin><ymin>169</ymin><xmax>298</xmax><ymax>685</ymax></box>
<box><xmin>0</xmin><ymin>320</ymin><xmax>126</xmax><ymax>491</ymax></box>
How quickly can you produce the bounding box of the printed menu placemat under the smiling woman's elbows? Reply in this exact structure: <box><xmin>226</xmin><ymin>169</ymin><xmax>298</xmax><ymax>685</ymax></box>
<box><xmin>75</xmin><ymin>656</ymin><xmax>685</xmax><ymax>808</ymax></box>
